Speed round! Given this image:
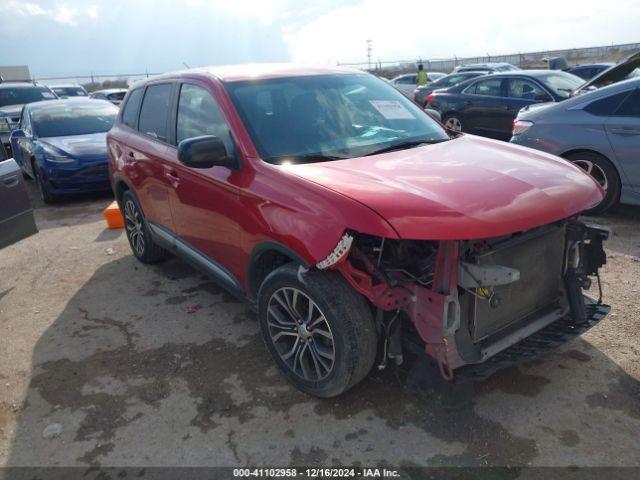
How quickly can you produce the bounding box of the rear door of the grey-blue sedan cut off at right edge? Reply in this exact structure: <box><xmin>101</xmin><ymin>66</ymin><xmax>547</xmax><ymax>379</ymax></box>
<box><xmin>605</xmin><ymin>88</ymin><xmax>640</xmax><ymax>192</ymax></box>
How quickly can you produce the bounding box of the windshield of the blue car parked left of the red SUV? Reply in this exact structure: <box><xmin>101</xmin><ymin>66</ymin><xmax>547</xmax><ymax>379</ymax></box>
<box><xmin>31</xmin><ymin>100</ymin><xmax>118</xmax><ymax>137</ymax></box>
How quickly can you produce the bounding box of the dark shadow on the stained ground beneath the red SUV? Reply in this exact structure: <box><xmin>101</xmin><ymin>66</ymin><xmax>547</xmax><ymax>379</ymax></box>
<box><xmin>8</xmin><ymin>256</ymin><xmax>640</xmax><ymax>466</ymax></box>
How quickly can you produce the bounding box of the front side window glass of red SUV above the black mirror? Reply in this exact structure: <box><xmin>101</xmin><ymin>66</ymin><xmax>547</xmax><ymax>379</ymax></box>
<box><xmin>176</xmin><ymin>83</ymin><xmax>234</xmax><ymax>152</ymax></box>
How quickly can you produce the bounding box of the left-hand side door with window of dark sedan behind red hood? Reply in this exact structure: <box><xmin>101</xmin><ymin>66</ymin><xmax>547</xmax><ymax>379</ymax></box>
<box><xmin>461</xmin><ymin>77</ymin><xmax>511</xmax><ymax>140</ymax></box>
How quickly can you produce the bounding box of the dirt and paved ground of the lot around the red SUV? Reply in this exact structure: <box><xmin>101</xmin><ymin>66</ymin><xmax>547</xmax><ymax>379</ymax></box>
<box><xmin>0</xmin><ymin>184</ymin><xmax>640</xmax><ymax>466</ymax></box>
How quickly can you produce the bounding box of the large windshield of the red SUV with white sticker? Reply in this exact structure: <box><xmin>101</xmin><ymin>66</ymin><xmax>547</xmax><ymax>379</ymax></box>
<box><xmin>226</xmin><ymin>74</ymin><xmax>449</xmax><ymax>163</ymax></box>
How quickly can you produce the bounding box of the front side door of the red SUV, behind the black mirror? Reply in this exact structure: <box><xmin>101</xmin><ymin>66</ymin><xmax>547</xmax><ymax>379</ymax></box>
<box><xmin>165</xmin><ymin>81</ymin><xmax>246</xmax><ymax>278</ymax></box>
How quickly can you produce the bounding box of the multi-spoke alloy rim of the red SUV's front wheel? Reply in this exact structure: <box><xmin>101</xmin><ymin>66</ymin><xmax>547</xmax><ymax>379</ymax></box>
<box><xmin>267</xmin><ymin>287</ymin><xmax>335</xmax><ymax>381</ymax></box>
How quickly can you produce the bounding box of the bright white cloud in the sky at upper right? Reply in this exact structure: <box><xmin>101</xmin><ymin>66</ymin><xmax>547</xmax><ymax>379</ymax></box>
<box><xmin>284</xmin><ymin>0</ymin><xmax>638</xmax><ymax>63</ymax></box>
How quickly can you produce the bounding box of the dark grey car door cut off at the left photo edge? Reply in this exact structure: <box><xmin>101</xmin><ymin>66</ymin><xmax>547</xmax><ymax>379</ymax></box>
<box><xmin>0</xmin><ymin>160</ymin><xmax>38</xmax><ymax>248</ymax></box>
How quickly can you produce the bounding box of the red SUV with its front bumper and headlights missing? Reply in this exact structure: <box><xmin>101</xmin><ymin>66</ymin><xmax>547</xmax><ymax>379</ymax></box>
<box><xmin>107</xmin><ymin>65</ymin><xmax>609</xmax><ymax>397</ymax></box>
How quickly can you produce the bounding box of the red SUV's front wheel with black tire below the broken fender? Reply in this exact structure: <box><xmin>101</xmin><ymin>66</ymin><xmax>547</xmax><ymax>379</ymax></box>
<box><xmin>258</xmin><ymin>263</ymin><xmax>378</xmax><ymax>398</ymax></box>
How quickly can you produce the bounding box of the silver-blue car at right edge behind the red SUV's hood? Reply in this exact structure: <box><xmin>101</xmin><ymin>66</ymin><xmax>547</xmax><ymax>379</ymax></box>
<box><xmin>511</xmin><ymin>78</ymin><xmax>640</xmax><ymax>214</ymax></box>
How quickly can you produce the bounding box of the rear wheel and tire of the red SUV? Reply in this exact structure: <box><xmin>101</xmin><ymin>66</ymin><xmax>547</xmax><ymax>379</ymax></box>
<box><xmin>120</xmin><ymin>190</ymin><xmax>170</xmax><ymax>263</ymax></box>
